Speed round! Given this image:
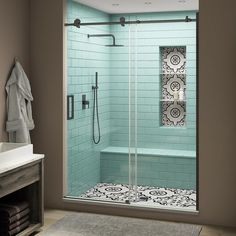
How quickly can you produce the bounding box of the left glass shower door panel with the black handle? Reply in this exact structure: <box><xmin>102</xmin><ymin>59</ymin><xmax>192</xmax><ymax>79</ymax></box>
<box><xmin>67</xmin><ymin>1</ymin><xmax>129</xmax><ymax>202</ymax></box>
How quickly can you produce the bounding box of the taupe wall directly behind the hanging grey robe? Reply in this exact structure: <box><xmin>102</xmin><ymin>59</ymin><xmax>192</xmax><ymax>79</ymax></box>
<box><xmin>0</xmin><ymin>0</ymin><xmax>30</xmax><ymax>142</ymax></box>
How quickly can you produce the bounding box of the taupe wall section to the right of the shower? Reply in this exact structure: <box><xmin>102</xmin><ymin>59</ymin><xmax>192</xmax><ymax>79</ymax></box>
<box><xmin>199</xmin><ymin>0</ymin><xmax>236</xmax><ymax>226</ymax></box>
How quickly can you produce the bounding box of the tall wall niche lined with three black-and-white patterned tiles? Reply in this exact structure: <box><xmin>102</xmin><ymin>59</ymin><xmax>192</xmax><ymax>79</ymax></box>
<box><xmin>160</xmin><ymin>47</ymin><xmax>186</xmax><ymax>126</ymax></box>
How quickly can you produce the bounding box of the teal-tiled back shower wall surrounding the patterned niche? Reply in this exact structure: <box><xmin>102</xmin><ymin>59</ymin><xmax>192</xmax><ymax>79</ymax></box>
<box><xmin>110</xmin><ymin>12</ymin><xmax>196</xmax><ymax>150</ymax></box>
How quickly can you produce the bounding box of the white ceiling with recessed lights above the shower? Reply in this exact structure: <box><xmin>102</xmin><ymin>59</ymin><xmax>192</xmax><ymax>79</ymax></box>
<box><xmin>75</xmin><ymin>0</ymin><xmax>199</xmax><ymax>14</ymax></box>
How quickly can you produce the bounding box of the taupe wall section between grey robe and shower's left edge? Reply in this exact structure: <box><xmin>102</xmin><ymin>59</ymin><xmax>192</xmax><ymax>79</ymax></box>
<box><xmin>30</xmin><ymin>0</ymin><xmax>64</xmax><ymax>208</ymax></box>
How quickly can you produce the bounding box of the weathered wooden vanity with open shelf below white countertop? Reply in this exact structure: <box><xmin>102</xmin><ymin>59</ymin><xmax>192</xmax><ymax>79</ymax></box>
<box><xmin>0</xmin><ymin>158</ymin><xmax>44</xmax><ymax>236</ymax></box>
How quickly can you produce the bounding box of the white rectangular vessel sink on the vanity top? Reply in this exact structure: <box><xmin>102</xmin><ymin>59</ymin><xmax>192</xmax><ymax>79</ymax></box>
<box><xmin>0</xmin><ymin>143</ymin><xmax>33</xmax><ymax>173</ymax></box>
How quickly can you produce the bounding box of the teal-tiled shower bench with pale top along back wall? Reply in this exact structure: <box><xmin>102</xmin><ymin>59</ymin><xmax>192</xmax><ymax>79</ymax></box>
<box><xmin>100</xmin><ymin>146</ymin><xmax>196</xmax><ymax>190</ymax></box>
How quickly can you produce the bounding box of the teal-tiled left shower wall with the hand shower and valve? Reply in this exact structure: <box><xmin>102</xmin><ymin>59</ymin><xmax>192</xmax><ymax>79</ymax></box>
<box><xmin>67</xmin><ymin>1</ymin><xmax>110</xmax><ymax>196</ymax></box>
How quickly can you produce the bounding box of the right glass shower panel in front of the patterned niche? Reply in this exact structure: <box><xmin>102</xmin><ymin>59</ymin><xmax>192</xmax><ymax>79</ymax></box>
<box><xmin>137</xmin><ymin>12</ymin><xmax>196</xmax><ymax>210</ymax></box>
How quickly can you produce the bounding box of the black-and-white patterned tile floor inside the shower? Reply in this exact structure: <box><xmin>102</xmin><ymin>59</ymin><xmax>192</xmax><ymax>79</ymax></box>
<box><xmin>79</xmin><ymin>183</ymin><xmax>196</xmax><ymax>210</ymax></box>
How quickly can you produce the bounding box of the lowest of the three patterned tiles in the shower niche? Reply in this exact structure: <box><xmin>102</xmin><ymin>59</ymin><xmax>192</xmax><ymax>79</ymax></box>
<box><xmin>162</xmin><ymin>101</ymin><xmax>186</xmax><ymax>126</ymax></box>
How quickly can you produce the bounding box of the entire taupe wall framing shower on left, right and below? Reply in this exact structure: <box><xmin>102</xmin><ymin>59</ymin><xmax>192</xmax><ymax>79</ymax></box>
<box><xmin>31</xmin><ymin>0</ymin><xmax>236</xmax><ymax>229</ymax></box>
